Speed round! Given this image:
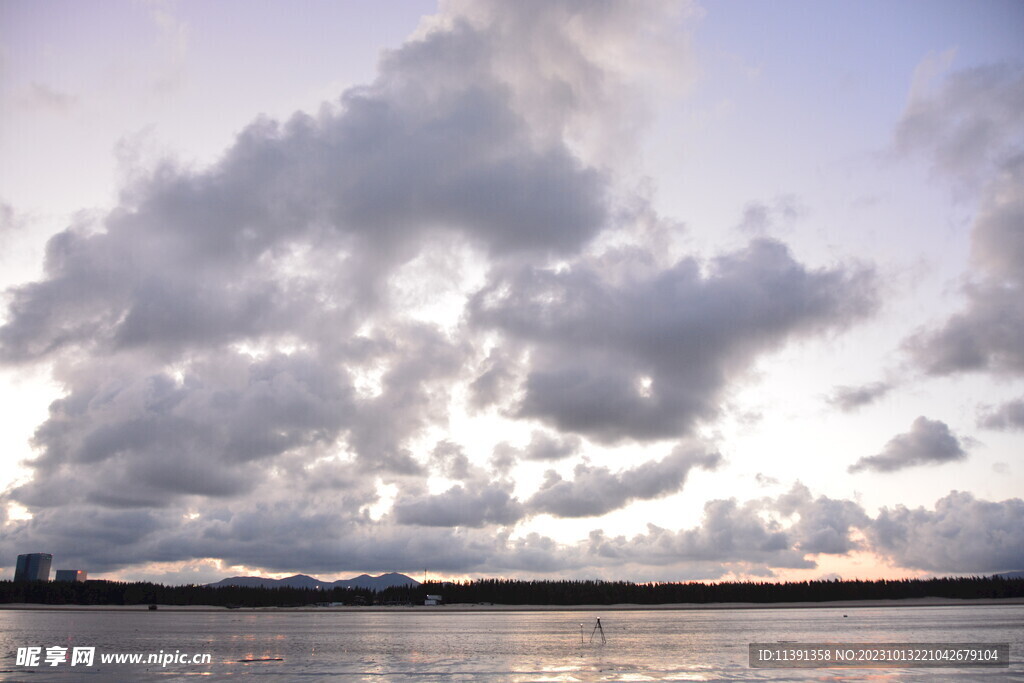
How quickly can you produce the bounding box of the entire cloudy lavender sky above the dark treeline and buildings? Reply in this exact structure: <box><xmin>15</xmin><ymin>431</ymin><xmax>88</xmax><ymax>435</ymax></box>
<box><xmin>0</xmin><ymin>0</ymin><xmax>1024</xmax><ymax>584</ymax></box>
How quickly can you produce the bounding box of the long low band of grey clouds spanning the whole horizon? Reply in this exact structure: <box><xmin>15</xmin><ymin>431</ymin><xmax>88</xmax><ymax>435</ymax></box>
<box><xmin>0</xmin><ymin>479</ymin><xmax>1024</xmax><ymax>579</ymax></box>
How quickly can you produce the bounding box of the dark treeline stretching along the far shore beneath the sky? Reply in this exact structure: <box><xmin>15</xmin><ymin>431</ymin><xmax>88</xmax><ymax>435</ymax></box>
<box><xmin>0</xmin><ymin>577</ymin><xmax>1024</xmax><ymax>607</ymax></box>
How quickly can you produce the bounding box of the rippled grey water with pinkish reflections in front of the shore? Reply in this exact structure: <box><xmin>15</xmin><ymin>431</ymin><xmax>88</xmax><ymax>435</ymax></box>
<box><xmin>0</xmin><ymin>604</ymin><xmax>1024</xmax><ymax>683</ymax></box>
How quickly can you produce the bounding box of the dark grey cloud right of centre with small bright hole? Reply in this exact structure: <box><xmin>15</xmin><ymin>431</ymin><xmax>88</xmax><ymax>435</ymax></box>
<box><xmin>471</xmin><ymin>240</ymin><xmax>873</xmax><ymax>441</ymax></box>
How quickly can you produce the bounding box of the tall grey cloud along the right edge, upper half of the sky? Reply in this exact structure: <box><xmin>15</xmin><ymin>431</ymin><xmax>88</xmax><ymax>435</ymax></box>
<box><xmin>897</xmin><ymin>65</ymin><xmax>1024</xmax><ymax>375</ymax></box>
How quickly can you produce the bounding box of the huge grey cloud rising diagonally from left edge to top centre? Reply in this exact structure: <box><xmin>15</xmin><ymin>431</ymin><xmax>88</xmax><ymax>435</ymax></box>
<box><xmin>0</xmin><ymin>3</ymin><xmax>626</xmax><ymax>362</ymax></box>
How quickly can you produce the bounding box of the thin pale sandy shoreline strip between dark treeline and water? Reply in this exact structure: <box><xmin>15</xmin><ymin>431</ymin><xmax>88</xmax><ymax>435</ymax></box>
<box><xmin>0</xmin><ymin>598</ymin><xmax>1024</xmax><ymax>614</ymax></box>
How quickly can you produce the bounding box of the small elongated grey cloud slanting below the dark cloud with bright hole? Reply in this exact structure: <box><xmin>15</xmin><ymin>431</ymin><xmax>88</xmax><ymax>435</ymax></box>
<box><xmin>526</xmin><ymin>446</ymin><xmax>722</xmax><ymax>517</ymax></box>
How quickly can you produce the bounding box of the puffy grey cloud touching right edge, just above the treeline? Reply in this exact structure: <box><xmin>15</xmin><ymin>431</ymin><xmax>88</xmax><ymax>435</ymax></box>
<box><xmin>865</xmin><ymin>492</ymin><xmax>1024</xmax><ymax>573</ymax></box>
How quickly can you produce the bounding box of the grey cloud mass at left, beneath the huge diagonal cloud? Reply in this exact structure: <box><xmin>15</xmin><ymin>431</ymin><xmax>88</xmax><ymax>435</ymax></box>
<box><xmin>12</xmin><ymin>354</ymin><xmax>354</xmax><ymax>508</ymax></box>
